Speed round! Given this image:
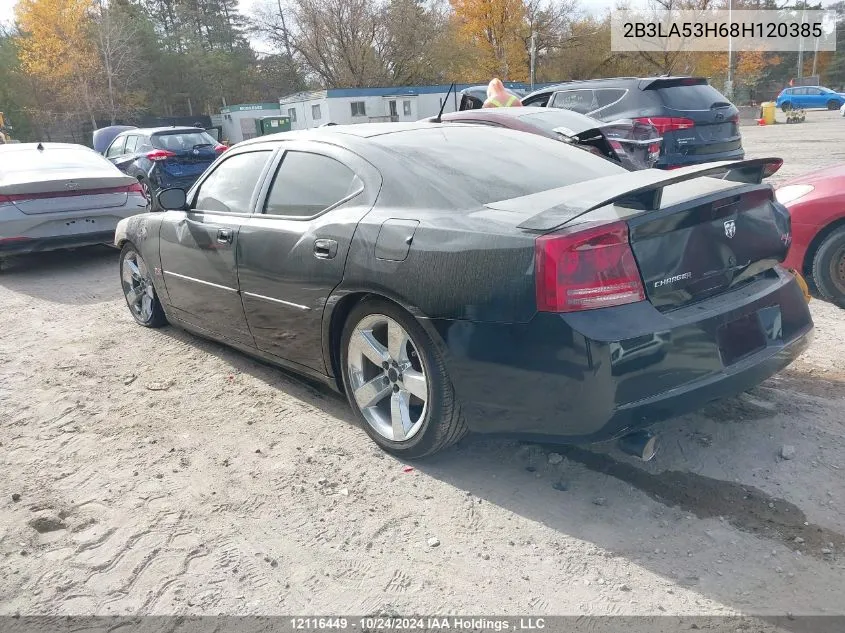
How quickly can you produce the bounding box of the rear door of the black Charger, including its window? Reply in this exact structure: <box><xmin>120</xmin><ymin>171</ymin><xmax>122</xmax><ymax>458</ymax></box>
<box><xmin>237</xmin><ymin>141</ymin><xmax>381</xmax><ymax>374</ymax></box>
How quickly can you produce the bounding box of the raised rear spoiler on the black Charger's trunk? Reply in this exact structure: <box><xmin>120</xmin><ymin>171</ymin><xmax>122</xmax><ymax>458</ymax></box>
<box><xmin>486</xmin><ymin>158</ymin><xmax>783</xmax><ymax>231</ymax></box>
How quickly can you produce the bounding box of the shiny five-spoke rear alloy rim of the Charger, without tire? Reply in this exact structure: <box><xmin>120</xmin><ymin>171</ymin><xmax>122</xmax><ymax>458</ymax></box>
<box><xmin>346</xmin><ymin>314</ymin><xmax>429</xmax><ymax>442</ymax></box>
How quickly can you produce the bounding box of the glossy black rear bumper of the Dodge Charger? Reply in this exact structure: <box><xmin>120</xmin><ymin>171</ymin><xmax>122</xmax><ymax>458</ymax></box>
<box><xmin>433</xmin><ymin>271</ymin><xmax>813</xmax><ymax>442</ymax></box>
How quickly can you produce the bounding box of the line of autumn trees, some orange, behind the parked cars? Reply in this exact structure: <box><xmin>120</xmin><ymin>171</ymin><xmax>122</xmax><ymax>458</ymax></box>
<box><xmin>0</xmin><ymin>0</ymin><xmax>845</xmax><ymax>140</ymax></box>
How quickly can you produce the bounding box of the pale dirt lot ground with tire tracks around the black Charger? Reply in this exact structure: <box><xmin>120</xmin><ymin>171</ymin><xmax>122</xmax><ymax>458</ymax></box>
<box><xmin>0</xmin><ymin>112</ymin><xmax>845</xmax><ymax>615</ymax></box>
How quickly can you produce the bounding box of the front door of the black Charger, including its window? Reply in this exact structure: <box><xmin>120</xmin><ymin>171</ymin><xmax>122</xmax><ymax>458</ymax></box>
<box><xmin>159</xmin><ymin>144</ymin><xmax>276</xmax><ymax>346</ymax></box>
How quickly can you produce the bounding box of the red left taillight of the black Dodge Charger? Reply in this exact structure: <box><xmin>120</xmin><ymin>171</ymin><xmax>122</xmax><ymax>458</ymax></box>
<box><xmin>534</xmin><ymin>222</ymin><xmax>645</xmax><ymax>312</ymax></box>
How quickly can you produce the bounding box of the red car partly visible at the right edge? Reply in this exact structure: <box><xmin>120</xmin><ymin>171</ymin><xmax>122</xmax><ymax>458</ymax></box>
<box><xmin>776</xmin><ymin>164</ymin><xmax>845</xmax><ymax>308</ymax></box>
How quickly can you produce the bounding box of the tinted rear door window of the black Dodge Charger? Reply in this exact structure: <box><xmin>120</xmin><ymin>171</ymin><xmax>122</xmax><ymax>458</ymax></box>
<box><xmin>264</xmin><ymin>151</ymin><xmax>361</xmax><ymax>217</ymax></box>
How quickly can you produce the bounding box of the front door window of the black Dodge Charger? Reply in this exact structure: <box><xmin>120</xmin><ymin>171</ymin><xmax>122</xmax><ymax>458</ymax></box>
<box><xmin>194</xmin><ymin>150</ymin><xmax>272</xmax><ymax>213</ymax></box>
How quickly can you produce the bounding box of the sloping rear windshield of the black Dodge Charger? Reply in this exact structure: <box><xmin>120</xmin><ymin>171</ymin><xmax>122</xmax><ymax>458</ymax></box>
<box><xmin>375</xmin><ymin>124</ymin><xmax>627</xmax><ymax>204</ymax></box>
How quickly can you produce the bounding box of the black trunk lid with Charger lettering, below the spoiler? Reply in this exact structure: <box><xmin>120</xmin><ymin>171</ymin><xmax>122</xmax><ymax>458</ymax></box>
<box><xmin>627</xmin><ymin>179</ymin><xmax>791</xmax><ymax>310</ymax></box>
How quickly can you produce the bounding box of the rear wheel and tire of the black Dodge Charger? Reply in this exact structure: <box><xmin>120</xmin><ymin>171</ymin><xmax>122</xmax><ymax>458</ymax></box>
<box><xmin>341</xmin><ymin>299</ymin><xmax>467</xmax><ymax>459</ymax></box>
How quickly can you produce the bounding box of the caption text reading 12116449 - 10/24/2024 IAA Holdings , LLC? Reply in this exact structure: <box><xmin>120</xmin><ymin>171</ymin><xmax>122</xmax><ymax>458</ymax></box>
<box><xmin>290</xmin><ymin>616</ymin><xmax>546</xmax><ymax>633</ymax></box>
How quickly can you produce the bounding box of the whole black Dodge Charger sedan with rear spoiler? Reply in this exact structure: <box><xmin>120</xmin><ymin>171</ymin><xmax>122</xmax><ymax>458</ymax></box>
<box><xmin>115</xmin><ymin>122</ymin><xmax>813</xmax><ymax>458</ymax></box>
